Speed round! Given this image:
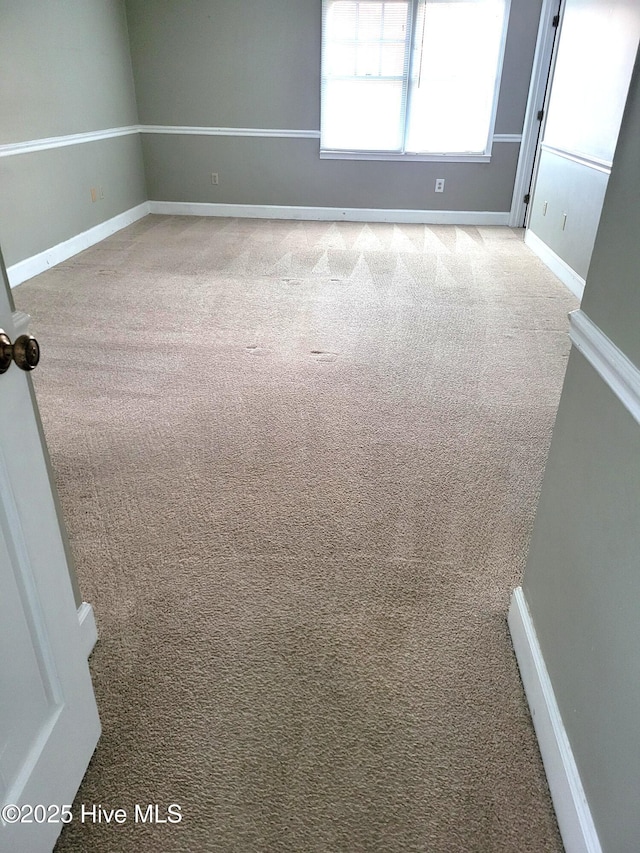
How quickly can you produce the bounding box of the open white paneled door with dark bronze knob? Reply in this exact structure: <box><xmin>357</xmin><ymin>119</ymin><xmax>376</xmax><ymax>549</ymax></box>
<box><xmin>0</xmin><ymin>248</ymin><xmax>100</xmax><ymax>853</ymax></box>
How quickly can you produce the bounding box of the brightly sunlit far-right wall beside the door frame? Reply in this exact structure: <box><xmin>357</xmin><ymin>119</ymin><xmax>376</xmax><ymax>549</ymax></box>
<box><xmin>529</xmin><ymin>0</ymin><xmax>640</xmax><ymax>278</ymax></box>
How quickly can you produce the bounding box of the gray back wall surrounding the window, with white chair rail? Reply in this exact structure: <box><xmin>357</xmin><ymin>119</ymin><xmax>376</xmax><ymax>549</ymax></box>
<box><xmin>127</xmin><ymin>0</ymin><xmax>541</xmax><ymax>211</ymax></box>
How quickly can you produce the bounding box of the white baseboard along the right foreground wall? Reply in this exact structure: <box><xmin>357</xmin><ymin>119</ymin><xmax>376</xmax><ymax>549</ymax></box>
<box><xmin>509</xmin><ymin>587</ymin><xmax>602</xmax><ymax>853</ymax></box>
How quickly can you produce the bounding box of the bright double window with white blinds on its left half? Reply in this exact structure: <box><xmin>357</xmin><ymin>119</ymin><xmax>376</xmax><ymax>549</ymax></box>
<box><xmin>321</xmin><ymin>0</ymin><xmax>509</xmax><ymax>158</ymax></box>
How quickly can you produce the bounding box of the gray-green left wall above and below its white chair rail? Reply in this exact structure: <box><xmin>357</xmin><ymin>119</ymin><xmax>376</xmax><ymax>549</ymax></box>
<box><xmin>0</xmin><ymin>0</ymin><xmax>146</xmax><ymax>266</ymax></box>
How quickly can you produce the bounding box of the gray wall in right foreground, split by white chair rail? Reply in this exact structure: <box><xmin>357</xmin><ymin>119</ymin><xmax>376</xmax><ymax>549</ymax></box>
<box><xmin>523</xmin><ymin>48</ymin><xmax>640</xmax><ymax>853</ymax></box>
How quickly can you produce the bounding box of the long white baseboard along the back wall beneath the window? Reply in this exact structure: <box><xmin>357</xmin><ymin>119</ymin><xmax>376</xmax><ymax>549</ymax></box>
<box><xmin>149</xmin><ymin>201</ymin><xmax>509</xmax><ymax>225</ymax></box>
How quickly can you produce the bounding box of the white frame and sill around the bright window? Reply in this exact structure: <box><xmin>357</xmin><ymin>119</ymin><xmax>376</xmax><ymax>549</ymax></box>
<box><xmin>320</xmin><ymin>0</ymin><xmax>511</xmax><ymax>163</ymax></box>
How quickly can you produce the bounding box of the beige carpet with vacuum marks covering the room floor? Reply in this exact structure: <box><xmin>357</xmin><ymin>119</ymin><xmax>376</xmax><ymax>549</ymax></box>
<box><xmin>15</xmin><ymin>217</ymin><xmax>576</xmax><ymax>853</ymax></box>
